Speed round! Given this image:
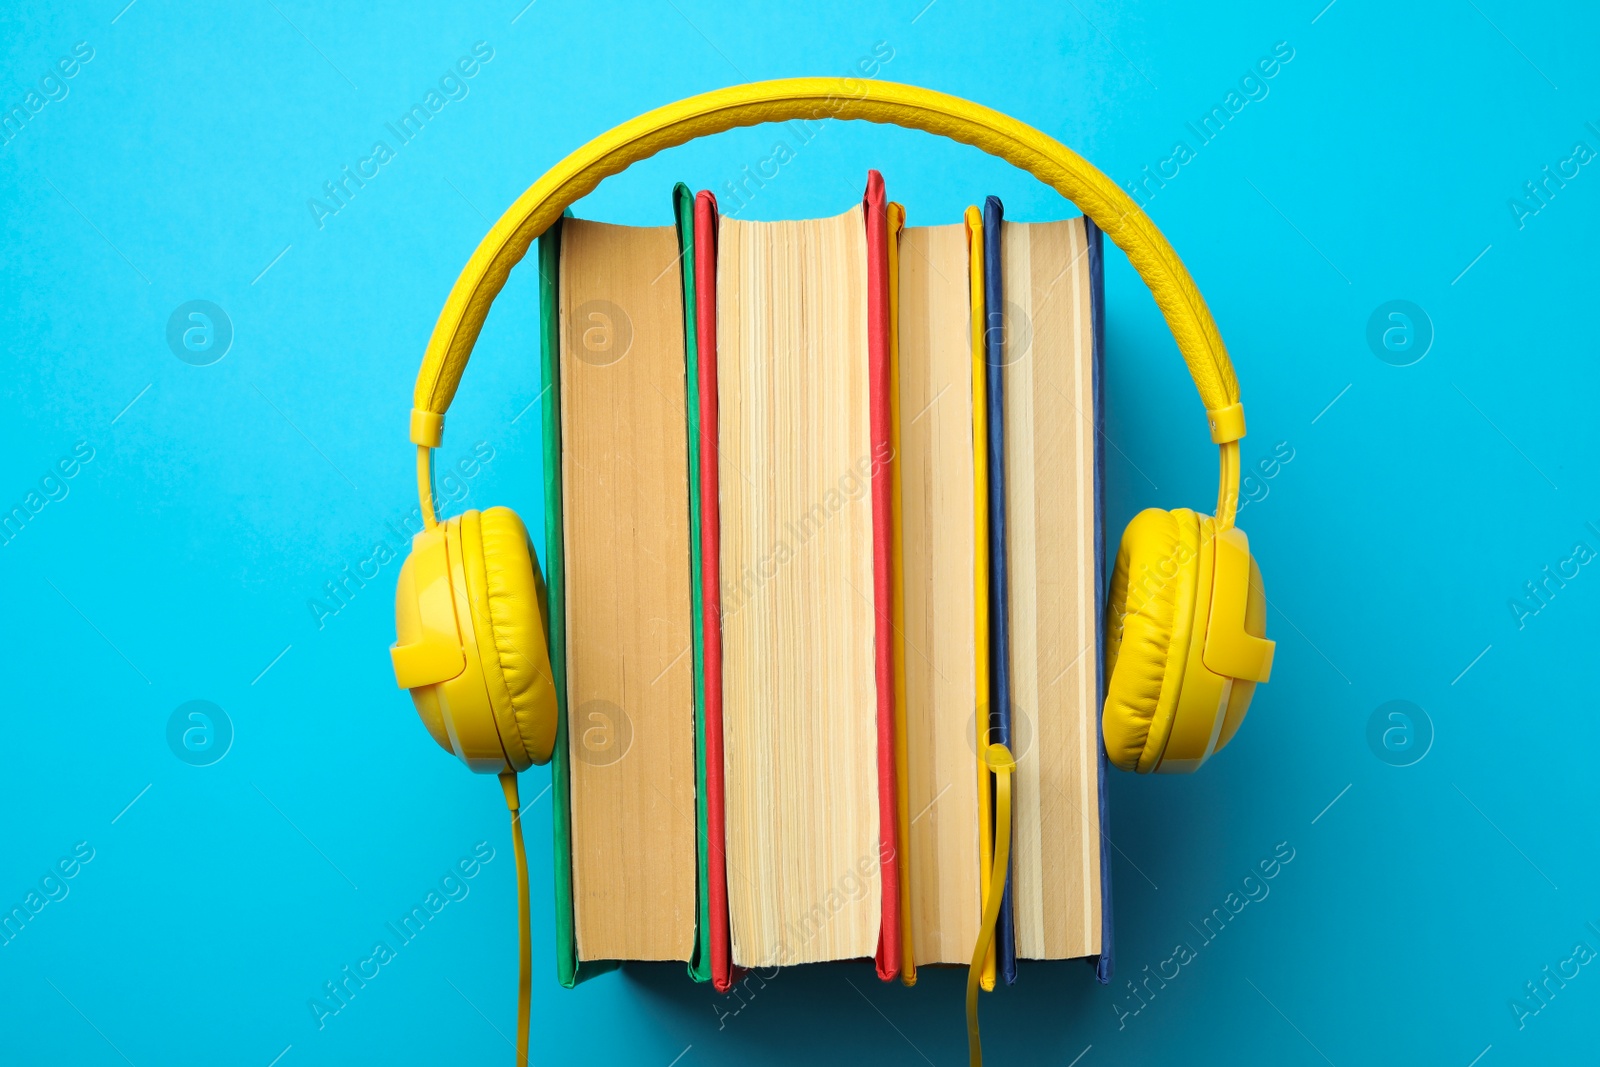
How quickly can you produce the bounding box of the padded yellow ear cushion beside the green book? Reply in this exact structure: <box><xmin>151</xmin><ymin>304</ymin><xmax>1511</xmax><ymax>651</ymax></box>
<box><xmin>461</xmin><ymin>507</ymin><xmax>555</xmax><ymax>771</ymax></box>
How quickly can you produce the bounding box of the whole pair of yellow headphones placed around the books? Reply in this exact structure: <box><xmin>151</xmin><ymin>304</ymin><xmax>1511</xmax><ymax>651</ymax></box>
<box><xmin>392</xmin><ymin>78</ymin><xmax>1274</xmax><ymax>1062</ymax></box>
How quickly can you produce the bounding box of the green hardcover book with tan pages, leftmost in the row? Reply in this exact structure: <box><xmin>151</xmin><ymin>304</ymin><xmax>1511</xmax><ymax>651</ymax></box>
<box><xmin>538</xmin><ymin>186</ymin><xmax>710</xmax><ymax>987</ymax></box>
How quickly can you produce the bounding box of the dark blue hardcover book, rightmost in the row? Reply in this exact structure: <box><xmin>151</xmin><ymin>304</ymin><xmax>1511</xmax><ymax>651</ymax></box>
<box><xmin>984</xmin><ymin>197</ymin><xmax>1112</xmax><ymax>984</ymax></box>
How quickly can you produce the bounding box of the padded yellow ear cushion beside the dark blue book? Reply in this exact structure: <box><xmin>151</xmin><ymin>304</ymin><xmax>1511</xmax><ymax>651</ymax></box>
<box><xmin>1101</xmin><ymin>507</ymin><xmax>1211</xmax><ymax>773</ymax></box>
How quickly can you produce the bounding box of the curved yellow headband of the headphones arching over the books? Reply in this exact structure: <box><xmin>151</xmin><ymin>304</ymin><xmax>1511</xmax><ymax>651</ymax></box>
<box><xmin>411</xmin><ymin>78</ymin><xmax>1245</xmax><ymax>528</ymax></box>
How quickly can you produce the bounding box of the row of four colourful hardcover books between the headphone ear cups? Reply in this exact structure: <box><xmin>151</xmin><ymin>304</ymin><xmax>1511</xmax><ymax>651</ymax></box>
<box><xmin>539</xmin><ymin>171</ymin><xmax>1112</xmax><ymax>990</ymax></box>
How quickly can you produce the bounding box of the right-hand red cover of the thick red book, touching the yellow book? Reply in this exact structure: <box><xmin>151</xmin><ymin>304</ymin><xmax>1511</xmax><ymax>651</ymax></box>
<box><xmin>862</xmin><ymin>171</ymin><xmax>901</xmax><ymax>981</ymax></box>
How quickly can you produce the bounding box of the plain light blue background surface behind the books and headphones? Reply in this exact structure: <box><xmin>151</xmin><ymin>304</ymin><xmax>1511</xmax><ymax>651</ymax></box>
<box><xmin>0</xmin><ymin>0</ymin><xmax>1600</xmax><ymax>1067</ymax></box>
